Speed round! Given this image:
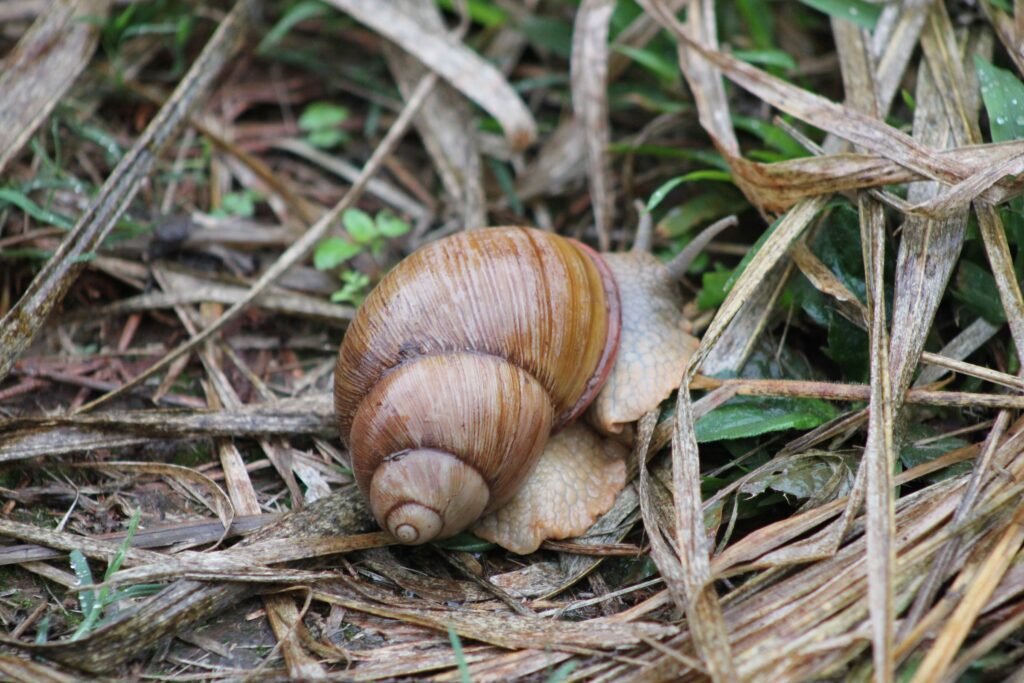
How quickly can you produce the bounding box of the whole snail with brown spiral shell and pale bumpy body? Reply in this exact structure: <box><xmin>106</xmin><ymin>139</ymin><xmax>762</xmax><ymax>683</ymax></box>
<box><xmin>334</xmin><ymin>222</ymin><xmax>724</xmax><ymax>553</ymax></box>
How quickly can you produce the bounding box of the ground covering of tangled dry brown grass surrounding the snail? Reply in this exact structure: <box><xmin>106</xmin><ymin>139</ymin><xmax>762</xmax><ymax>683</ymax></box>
<box><xmin>0</xmin><ymin>0</ymin><xmax>1024</xmax><ymax>682</ymax></box>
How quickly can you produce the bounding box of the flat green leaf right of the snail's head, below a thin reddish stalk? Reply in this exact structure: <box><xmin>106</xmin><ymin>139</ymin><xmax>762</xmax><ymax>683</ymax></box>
<box><xmin>695</xmin><ymin>396</ymin><xmax>839</xmax><ymax>443</ymax></box>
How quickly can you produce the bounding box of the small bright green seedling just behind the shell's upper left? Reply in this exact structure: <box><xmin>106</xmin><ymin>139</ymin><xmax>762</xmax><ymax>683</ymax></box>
<box><xmin>313</xmin><ymin>209</ymin><xmax>410</xmax><ymax>306</ymax></box>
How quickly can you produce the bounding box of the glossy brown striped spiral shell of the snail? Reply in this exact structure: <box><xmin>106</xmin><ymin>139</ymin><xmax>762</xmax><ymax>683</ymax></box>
<box><xmin>335</xmin><ymin>227</ymin><xmax>621</xmax><ymax>544</ymax></box>
